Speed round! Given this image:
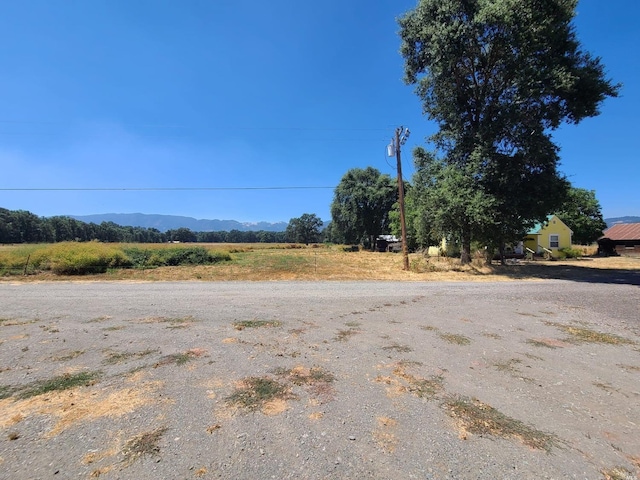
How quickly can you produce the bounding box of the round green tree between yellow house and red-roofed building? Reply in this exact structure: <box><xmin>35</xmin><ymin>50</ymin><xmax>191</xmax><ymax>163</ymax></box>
<box><xmin>556</xmin><ymin>187</ymin><xmax>607</xmax><ymax>245</ymax></box>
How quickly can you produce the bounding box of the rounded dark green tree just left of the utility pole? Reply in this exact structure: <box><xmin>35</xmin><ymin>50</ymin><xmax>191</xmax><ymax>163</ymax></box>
<box><xmin>331</xmin><ymin>167</ymin><xmax>398</xmax><ymax>248</ymax></box>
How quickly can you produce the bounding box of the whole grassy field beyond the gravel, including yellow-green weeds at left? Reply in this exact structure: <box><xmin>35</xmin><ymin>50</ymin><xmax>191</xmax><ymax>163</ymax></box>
<box><xmin>0</xmin><ymin>240</ymin><xmax>640</xmax><ymax>281</ymax></box>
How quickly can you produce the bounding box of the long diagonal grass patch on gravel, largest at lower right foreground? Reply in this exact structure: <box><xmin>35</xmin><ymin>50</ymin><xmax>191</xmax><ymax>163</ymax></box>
<box><xmin>443</xmin><ymin>397</ymin><xmax>557</xmax><ymax>452</ymax></box>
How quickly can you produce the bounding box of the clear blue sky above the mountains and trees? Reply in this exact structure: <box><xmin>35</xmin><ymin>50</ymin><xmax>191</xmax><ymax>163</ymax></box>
<box><xmin>0</xmin><ymin>0</ymin><xmax>640</xmax><ymax>222</ymax></box>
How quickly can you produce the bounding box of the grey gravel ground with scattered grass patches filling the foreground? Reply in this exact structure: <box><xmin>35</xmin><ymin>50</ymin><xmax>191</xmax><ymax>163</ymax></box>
<box><xmin>0</xmin><ymin>280</ymin><xmax>640</xmax><ymax>480</ymax></box>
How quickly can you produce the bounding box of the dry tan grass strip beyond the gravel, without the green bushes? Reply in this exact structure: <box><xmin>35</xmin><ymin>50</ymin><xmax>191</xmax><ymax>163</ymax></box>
<box><xmin>0</xmin><ymin>244</ymin><xmax>640</xmax><ymax>282</ymax></box>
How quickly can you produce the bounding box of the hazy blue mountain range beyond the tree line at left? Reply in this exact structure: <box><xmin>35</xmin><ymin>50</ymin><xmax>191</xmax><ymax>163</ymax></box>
<box><xmin>68</xmin><ymin>213</ymin><xmax>288</xmax><ymax>232</ymax></box>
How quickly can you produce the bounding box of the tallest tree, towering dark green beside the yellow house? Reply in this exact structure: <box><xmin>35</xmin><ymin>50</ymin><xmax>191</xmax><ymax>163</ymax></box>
<box><xmin>399</xmin><ymin>0</ymin><xmax>619</xmax><ymax>262</ymax></box>
